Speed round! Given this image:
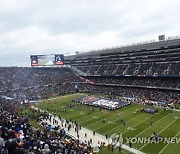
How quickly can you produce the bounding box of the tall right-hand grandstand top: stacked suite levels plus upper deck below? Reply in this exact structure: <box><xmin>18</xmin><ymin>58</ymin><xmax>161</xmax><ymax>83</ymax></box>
<box><xmin>65</xmin><ymin>38</ymin><xmax>180</xmax><ymax>76</ymax></box>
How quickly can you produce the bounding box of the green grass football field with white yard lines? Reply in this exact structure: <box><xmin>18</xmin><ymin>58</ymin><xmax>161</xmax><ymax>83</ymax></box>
<box><xmin>36</xmin><ymin>94</ymin><xmax>180</xmax><ymax>154</ymax></box>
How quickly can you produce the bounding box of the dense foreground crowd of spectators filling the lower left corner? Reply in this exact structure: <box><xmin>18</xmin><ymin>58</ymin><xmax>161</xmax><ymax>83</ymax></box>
<box><xmin>0</xmin><ymin>99</ymin><xmax>95</xmax><ymax>154</ymax></box>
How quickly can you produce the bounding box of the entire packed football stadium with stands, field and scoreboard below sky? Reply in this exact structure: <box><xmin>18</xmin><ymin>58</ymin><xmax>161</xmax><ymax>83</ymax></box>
<box><xmin>0</xmin><ymin>36</ymin><xmax>180</xmax><ymax>154</ymax></box>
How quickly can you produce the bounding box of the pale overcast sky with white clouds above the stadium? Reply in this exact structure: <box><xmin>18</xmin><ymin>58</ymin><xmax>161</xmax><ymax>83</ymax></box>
<box><xmin>0</xmin><ymin>0</ymin><xmax>180</xmax><ymax>66</ymax></box>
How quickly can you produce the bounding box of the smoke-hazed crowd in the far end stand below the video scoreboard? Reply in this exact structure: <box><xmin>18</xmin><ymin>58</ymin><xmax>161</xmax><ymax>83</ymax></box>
<box><xmin>0</xmin><ymin>67</ymin><xmax>79</xmax><ymax>100</ymax></box>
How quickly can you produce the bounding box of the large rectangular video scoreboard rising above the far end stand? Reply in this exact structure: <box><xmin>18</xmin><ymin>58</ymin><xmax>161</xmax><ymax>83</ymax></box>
<box><xmin>30</xmin><ymin>54</ymin><xmax>64</xmax><ymax>66</ymax></box>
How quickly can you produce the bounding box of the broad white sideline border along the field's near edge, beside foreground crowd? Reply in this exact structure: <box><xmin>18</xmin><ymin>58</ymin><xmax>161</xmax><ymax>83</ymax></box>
<box><xmin>31</xmin><ymin>106</ymin><xmax>145</xmax><ymax>154</ymax></box>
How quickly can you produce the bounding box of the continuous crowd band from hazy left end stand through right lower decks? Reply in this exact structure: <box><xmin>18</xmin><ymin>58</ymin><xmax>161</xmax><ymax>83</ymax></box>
<box><xmin>0</xmin><ymin>67</ymin><xmax>180</xmax><ymax>104</ymax></box>
